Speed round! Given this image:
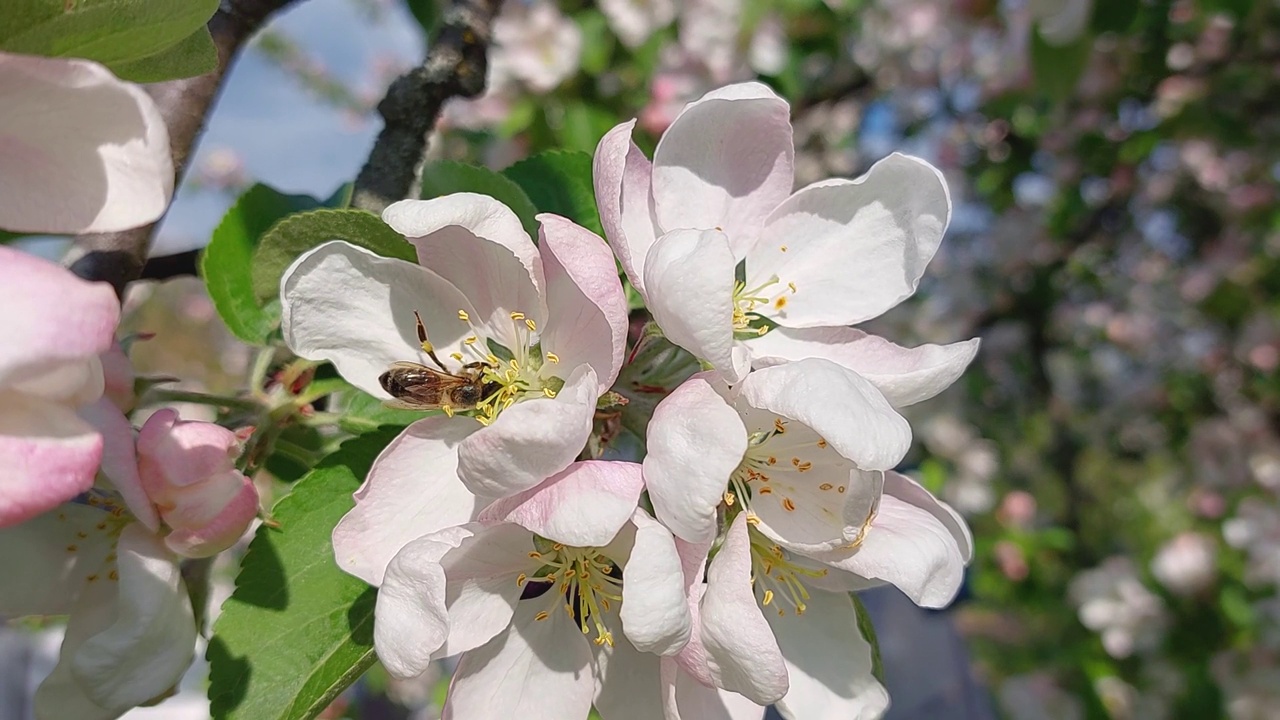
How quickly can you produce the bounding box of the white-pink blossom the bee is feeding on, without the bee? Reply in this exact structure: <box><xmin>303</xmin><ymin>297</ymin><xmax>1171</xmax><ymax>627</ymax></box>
<box><xmin>288</xmin><ymin>193</ymin><xmax>627</xmax><ymax>584</ymax></box>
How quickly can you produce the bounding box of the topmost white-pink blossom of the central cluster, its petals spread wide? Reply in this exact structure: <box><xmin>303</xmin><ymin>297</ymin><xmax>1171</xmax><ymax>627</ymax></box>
<box><xmin>594</xmin><ymin>82</ymin><xmax>978</xmax><ymax>397</ymax></box>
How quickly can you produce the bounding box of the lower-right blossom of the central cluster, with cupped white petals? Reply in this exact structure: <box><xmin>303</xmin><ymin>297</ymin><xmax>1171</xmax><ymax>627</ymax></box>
<box><xmin>644</xmin><ymin>359</ymin><xmax>973</xmax><ymax>719</ymax></box>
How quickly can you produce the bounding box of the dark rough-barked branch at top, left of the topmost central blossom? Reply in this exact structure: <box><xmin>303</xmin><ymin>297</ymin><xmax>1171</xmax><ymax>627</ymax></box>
<box><xmin>352</xmin><ymin>0</ymin><xmax>502</xmax><ymax>213</ymax></box>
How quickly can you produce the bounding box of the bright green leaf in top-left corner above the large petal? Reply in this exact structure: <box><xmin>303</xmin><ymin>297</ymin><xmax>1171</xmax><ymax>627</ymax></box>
<box><xmin>0</xmin><ymin>0</ymin><xmax>218</xmax><ymax>71</ymax></box>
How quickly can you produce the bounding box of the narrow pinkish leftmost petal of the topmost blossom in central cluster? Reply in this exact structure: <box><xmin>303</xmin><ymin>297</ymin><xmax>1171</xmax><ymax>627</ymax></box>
<box><xmin>591</xmin><ymin>120</ymin><xmax>660</xmax><ymax>296</ymax></box>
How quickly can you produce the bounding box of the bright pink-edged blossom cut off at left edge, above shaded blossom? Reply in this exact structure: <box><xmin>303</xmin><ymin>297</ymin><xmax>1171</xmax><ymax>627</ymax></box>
<box><xmin>0</xmin><ymin>247</ymin><xmax>120</xmax><ymax>527</ymax></box>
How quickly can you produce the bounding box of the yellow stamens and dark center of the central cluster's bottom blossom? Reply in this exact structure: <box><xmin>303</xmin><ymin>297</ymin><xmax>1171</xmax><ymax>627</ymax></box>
<box><xmin>516</xmin><ymin>538</ymin><xmax>622</xmax><ymax>647</ymax></box>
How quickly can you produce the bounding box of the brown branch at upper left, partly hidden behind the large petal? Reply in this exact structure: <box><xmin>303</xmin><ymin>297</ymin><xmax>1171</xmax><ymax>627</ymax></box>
<box><xmin>68</xmin><ymin>0</ymin><xmax>307</xmax><ymax>295</ymax></box>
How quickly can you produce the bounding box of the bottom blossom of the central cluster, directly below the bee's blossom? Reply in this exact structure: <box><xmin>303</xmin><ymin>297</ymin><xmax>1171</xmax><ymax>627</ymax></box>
<box><xmin>374</xmin><ymin>461</ymin><xmax>692</xmax><ymax>720</ymax></box>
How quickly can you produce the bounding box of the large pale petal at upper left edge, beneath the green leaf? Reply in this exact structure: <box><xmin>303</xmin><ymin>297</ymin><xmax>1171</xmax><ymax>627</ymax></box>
<box><xmin>0</xmin><ymin>53</ymin><xmax>174</xmax><ymax>233</ymax></box>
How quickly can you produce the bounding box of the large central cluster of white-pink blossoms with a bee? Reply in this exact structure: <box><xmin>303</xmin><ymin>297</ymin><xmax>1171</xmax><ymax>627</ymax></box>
<box><xmin>280</xmin><ymin>83</ymin><xmax>977</xmax><ymax>720</ymax></box>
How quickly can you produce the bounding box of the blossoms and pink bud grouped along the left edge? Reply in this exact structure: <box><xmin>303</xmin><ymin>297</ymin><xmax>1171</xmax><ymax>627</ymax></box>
<box><xmin>0</xmin><ymin>47</ymin><xmax>257</xmax><ymax>720</ymax></box>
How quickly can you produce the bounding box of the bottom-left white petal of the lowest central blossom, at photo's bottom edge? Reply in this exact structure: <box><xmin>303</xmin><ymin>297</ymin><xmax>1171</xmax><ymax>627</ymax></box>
<box><xmin>443</xmin><ymin>602</ymin><xmax>595</xmax><ymax>720</ymax></box>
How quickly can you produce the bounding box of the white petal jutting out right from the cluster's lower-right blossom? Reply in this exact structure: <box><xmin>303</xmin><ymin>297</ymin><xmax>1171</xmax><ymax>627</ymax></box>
<box><xmin>813</xmin><ymin>474</ymin><xmax>970</xmax><ymax>607</ymax></box>
